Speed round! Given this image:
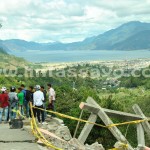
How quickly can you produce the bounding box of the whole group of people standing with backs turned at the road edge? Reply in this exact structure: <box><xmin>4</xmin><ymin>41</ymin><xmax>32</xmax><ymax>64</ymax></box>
<box><xmin>0</xmin><ymin>84</ymin><xmax>56</xmax><ymax>124</ymax></box>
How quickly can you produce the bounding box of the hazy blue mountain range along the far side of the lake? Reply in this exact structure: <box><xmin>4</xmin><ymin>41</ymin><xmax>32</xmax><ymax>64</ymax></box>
<box><xmin>0</xmin><ymin>21</ymin><xmax>150</xmax><ymax>53</ymax></box>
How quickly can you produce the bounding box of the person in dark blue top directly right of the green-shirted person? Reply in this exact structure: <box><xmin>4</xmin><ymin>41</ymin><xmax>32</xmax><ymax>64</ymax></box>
<box><xmin>21</xmin><ymin>84</ymin><xmax>30</xmax><ymax>118</ymax></box>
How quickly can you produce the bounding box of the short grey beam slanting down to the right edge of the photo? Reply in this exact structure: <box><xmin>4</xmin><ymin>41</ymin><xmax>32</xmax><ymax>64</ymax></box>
<box><xmin>132</xmin><ymin>104</ymin><xmax>150</xmax><ymax>136</ymax></box>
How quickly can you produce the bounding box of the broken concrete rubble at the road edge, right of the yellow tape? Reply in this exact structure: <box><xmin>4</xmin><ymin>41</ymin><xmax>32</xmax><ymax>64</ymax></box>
<box><xmin>41</xmin><ymin>118</ymin><xmax>104</xmax><ymax>150</ymax></box>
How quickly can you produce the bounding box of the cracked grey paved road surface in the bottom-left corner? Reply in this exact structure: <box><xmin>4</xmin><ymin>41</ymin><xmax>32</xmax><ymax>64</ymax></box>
<box><xmin>0</xmin><ymin>124</ymin><xmax>40</xmax><ymax>150</ymax></box>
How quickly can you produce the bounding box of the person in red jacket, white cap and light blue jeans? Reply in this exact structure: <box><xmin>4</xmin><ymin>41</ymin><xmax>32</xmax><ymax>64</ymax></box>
<box><xmin>0</xmin><ymin>87</ymin><xmax>9</xmax><ymax>123</ymax></box>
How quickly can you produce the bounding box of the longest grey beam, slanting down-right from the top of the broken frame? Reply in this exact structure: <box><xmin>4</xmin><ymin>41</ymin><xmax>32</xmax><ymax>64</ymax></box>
<box><xmin>87</xmin><ymin>97</ymin><xmax>133</xmax><ymax>150</ymax></box>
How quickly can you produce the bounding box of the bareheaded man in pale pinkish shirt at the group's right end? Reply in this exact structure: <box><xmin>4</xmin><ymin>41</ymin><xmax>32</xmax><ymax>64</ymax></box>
<box><xmin>47</xmin><ymin>84</ymin><xmax>56</xmax><ymax>117</ymax></box>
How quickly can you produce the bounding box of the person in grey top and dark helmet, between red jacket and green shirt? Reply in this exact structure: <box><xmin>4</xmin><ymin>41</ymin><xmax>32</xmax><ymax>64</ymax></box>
<box><xmin>8</xmin><ymin>86</ymin><xmax>18</xmax><ymax>120</ymax></box>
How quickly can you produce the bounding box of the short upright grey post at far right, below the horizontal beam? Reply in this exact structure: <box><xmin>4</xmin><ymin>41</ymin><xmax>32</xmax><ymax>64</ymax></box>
<box><xmin>137</xmin><ymin>123</ymin><xmax>145</xmax><ymax>148</ymax></box>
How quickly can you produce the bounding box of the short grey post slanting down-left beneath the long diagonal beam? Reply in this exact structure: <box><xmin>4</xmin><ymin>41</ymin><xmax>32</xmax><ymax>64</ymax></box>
<box><xmin>78</xmin><ymin>113</ymin><xmax>97</xmax><ymax>144</ymax></box>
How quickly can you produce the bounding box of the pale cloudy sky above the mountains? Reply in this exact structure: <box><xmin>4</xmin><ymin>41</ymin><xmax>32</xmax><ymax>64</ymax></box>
<box><xmin>0</xmin><ymin>0</ymin><xmax>150</xmax><ymax>43</ymax></box>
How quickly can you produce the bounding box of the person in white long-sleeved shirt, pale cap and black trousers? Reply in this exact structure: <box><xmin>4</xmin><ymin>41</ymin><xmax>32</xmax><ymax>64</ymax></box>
<box><xmin>33</xmin><ymin>85</ymin><xmax>46</xmax><ymax>124</ymax></box>
